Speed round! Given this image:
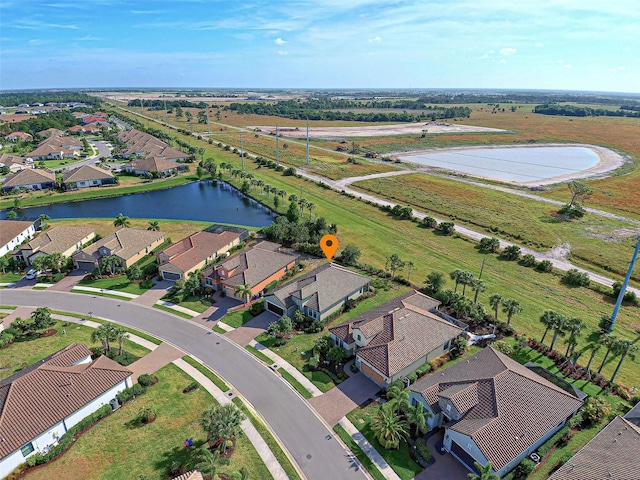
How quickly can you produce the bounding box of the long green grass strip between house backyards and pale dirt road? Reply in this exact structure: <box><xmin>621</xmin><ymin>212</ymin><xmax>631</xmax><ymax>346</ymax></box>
<box><xmin>109</xmin><ymin>108</ymin><xmax>640</xmax><ymax>385</ymax></box>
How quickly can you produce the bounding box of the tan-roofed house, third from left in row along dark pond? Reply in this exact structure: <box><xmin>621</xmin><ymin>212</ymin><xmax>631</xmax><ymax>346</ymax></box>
<box><xmin>71</xmin><ymin>228</ymin><xmax>164</xmax><ymax>272</ymax></box>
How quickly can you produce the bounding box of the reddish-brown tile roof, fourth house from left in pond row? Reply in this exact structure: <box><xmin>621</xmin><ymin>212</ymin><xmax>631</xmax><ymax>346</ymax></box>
<box><xmin>158</xmin><ymin>232</ymin><xmax>240</xmax><ymax>272</ymax></box>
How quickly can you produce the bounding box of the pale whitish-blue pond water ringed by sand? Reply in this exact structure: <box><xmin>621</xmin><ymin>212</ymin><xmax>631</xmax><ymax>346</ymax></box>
<box><xmin>399</xmin><ymin>146</ymin><xmax>600</xmax><ymax>183</ymax></box>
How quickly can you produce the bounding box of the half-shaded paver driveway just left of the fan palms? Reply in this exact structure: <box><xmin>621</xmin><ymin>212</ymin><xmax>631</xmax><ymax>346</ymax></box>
<box><xmin>309</xmin><ymin>372</ymin><xmax>380</xmax><ymax>426</ymax></box>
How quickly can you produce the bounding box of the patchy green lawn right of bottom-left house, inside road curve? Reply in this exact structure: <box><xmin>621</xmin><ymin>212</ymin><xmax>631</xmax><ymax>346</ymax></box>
<box><xmin>25</xmin><ymin>365</ymin><xmax>270</xmax><ymax>480</ymax></box>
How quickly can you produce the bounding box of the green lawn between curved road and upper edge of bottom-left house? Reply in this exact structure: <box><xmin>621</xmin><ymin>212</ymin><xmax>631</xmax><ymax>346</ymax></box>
<box><xmin>0</xmin><ymin>321</ymin><xmax>149</xmax><ymax>378</ymax></box>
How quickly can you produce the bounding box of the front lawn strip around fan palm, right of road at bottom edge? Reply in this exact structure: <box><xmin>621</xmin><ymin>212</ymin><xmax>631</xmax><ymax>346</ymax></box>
<box><xmin>347</xmin><ymin>404</ymin><xmax>422</xmax><ymax>480</ymax></box>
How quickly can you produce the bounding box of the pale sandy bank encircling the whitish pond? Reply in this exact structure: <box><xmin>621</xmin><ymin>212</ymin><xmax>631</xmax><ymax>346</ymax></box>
<box><xmin>398</xmin><ymin>143</ymin><xmax>625</xmax><ymax>187</ymax></box>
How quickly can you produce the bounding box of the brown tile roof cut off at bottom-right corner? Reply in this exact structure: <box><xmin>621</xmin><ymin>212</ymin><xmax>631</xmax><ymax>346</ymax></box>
<box><xmin>549</xmin><ymin>417</ymin><xmax>640</xmax><ymax>480</ymax></box>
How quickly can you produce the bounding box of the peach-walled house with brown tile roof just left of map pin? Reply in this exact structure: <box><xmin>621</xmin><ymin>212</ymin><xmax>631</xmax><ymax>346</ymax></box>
<box><xmin>201</xmin><ymin>242</ymin><xmax>299</xmax><ymax>298</ymax></box>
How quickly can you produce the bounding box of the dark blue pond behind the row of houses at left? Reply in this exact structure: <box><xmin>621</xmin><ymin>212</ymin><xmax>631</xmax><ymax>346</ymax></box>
<box><xmin>0</xmin><ymin>180</ymin><xmax>274</xmax><ymax>227</ymax></box>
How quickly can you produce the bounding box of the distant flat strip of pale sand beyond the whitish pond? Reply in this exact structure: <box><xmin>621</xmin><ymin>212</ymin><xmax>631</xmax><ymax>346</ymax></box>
<box><xmin>247</xmin><ymin>122</ymin><xmax>506</xmax><ymax>139</ymax></box>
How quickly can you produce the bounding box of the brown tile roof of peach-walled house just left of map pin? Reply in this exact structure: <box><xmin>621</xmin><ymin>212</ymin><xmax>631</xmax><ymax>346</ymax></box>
<box><xmin>204</xmin><ymin>242</ymin><xmax>298</xmax><ymax>286</ymax></box>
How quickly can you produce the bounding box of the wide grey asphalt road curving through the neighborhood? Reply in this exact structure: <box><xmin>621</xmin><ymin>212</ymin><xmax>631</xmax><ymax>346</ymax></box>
<box><xmin>0</xmin><ymin>288</ymin><xmax>366</xmax><ymax>480</ymax></box>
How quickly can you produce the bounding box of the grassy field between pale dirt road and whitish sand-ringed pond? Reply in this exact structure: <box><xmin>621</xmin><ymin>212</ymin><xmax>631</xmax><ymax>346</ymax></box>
<box><xmin>352</xmin><ymin>174</ymin><xmax>640</xmax><ymax>284</ymax></box>
